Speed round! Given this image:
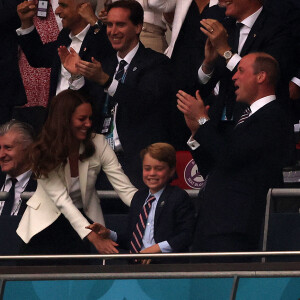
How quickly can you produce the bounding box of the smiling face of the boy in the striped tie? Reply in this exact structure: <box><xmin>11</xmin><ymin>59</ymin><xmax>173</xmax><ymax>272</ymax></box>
<box><xmin>143</xmin><ymin>153</ymin><xmax>175</xmax><ymax>194</ymax></box>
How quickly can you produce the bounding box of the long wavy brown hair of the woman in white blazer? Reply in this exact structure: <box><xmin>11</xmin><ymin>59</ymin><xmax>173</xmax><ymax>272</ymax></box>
<box><xmin>30</xmin><ymin>89</ymin><xmax>95</xmax><ymax>178</ymax></box>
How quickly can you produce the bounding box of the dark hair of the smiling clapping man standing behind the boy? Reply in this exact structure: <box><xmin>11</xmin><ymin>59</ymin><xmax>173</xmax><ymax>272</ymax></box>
<box><xmin>107</xmin><ymin>0</ymin><xmax>144</xmax><ymax>25</ymax></box>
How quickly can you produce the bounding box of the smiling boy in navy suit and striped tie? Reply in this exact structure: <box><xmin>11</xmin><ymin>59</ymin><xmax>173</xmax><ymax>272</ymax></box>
<box><xmin>88</xmin><ymin>143</ymin><xmax>194</xmax><ymax>264</ymax></box>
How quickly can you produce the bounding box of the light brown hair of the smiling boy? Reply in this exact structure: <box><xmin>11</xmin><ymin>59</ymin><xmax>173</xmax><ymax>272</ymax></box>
<box><xmin>140</xmin><ymin>143</ymin><xmax>176</xmax><ymax>169</ymax></box>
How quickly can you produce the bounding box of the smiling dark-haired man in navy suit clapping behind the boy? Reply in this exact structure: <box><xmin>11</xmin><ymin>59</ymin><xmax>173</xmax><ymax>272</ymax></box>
<box><xmin>62</xmin><ymin>0</ymin><xmax>171</xmax><ymax>187</ymax></box>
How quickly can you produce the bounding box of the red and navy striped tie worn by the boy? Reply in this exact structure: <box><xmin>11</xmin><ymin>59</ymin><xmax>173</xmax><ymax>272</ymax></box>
<box><xmin>130</xmin><ymin>195</ymin><xmax>155</xmax><ymax>253</ymax></box>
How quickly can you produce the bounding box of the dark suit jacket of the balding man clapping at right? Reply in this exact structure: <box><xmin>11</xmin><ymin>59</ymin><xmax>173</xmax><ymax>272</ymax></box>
<box><xmin>192</xmin><ymin>100</ymin><xmax>289</xmax><ymax>248</ymax></box>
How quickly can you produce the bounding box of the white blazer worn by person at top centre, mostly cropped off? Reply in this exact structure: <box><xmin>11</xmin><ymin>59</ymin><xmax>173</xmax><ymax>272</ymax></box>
<box><xmin>148</xmin><ymin>0</ymin><xmax>219</xmax><ymax>57</ymax></box>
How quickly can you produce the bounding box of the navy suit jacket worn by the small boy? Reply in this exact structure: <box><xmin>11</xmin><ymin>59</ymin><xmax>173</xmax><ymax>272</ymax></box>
<box><xmin>118</xmin><ymin>185</ymin><xmax>194</xmax><ymax>252</ymax></box>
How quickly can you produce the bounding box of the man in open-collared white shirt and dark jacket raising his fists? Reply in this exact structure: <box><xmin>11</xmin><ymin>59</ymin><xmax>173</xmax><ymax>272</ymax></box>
<box><xmin>17</xmin><ymin>0</ymin><xmax>114</xmax><ymax>125</ymax></box>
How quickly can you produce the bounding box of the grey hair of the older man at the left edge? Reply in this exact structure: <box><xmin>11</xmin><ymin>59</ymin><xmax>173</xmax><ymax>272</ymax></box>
<box><xmin>0</xmin><ymin>119</ymin><xmax>35</xmax><ymax>146</ymax></box>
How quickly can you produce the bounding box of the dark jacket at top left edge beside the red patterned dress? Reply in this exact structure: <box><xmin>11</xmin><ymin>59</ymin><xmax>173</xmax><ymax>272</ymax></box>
<box><xmin>0</xmin><ymin>0</ymin><xmax>27</xmax><ymax>106</ymax></box>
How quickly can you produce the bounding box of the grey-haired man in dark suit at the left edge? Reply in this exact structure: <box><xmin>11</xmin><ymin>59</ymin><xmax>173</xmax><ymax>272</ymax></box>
<box><xmin>0</xmin><ymin>120</ymin><xmax>36</xmax><ymax>255</ymax></box>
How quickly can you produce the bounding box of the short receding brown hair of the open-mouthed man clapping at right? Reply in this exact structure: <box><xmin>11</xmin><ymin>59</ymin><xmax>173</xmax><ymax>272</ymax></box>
<box><xmin>252</xmin><ymin>52</ymin><xmax>279</xmax><ymax>87</ymax></box>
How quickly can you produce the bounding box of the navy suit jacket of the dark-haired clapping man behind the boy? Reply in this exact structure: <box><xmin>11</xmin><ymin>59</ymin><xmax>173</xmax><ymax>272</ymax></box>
<box><xmin>101</xmin><ymin>43</ymin><xmax>171</xmax><ymax>187</ymax></box>
